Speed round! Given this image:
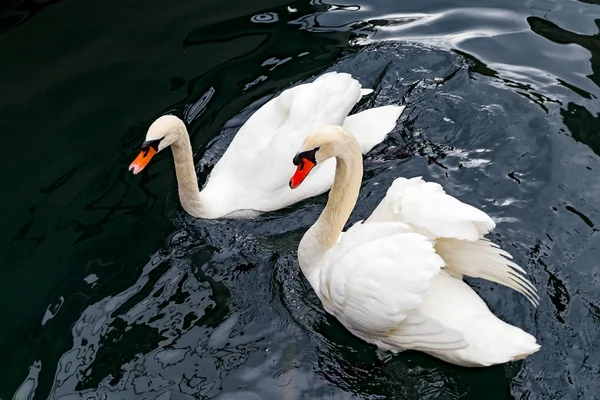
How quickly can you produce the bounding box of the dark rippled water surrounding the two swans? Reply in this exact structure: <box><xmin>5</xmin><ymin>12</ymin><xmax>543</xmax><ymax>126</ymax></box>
<box><xmin>0</xmin><ymin>0</ymin><xmax>600</xmax><ymax>400</ymax></box>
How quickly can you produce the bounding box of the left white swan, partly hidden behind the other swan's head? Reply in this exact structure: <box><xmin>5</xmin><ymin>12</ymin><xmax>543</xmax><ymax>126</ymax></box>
<box><xmin>129</xmin><ymin>72</ymin><xmax>404</xmax><ymax>219</ymax></box>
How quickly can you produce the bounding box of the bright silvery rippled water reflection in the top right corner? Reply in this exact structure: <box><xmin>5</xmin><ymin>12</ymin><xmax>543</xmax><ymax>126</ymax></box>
<box><xmin>327</xmin><ymin>1</ymin><xmax>600</xmax><ymax>115</ymax></box>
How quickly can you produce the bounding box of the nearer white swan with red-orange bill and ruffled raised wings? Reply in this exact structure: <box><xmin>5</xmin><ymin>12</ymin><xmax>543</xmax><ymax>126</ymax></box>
<box><xmin>290</xmin><ymin>126</ymin><xmax>540</xmax><ymax>367</ymax></box>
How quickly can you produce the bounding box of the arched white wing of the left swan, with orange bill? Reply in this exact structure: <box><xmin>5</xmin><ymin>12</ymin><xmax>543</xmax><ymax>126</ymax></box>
<box><xmin>209</xmin><ymin>72</ymin><xmax>361</xmax><ymax>192</ymax></box>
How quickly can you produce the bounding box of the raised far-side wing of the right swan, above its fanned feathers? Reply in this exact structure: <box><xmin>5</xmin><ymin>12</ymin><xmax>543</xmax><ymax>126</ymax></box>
<box><xmin>367</xmin><ymin>177</ymin><xmax>496</xmax><ymax>241</ymax></box>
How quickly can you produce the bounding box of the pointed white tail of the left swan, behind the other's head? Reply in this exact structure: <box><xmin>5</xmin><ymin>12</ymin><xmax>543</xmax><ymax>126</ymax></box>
<box><xmin>344</xmin><ymin>104</ymin><xmax>406</xmax><ymax>154</ymax></box>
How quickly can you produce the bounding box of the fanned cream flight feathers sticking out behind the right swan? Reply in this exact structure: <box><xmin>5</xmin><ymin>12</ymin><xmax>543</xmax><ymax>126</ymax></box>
<box><xmin>435</xmin><ymin>239</ymin><xmax>540</xmax><ymax>307</ymax></box>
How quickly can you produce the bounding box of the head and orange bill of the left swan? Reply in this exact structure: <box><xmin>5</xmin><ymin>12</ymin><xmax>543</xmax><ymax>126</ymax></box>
<box><xmin>129</xmin><ymin>115</ymin><xmax>186</xmax><ymax>174</ymax></box>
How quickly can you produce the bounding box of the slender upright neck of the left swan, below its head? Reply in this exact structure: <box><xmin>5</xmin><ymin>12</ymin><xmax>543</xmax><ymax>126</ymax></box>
<box><xmin>171</xmin><ymin>128</ymin><xmax>203</xmax><ymax>218</ymax></box>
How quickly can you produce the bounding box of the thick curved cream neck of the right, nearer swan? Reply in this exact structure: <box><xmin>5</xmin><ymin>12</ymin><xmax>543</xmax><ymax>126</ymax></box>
<box><xmin>298</xmin><ymin>134</ymin><xmax>363</xmax><ymax>289</ymax></box>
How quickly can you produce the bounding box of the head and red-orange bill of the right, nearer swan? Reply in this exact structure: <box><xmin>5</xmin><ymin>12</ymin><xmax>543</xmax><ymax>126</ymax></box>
<box><xmin>290</xmin><ymin>125</ymin><xmax>358</xmax><ymax>189</ymax></box>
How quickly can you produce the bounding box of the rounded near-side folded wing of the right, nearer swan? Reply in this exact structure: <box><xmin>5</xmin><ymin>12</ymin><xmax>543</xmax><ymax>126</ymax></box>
<box><xmin>319</xmin><ymin>223</ymin><xmax>466</xmax><ymax>350</ymax></box>
